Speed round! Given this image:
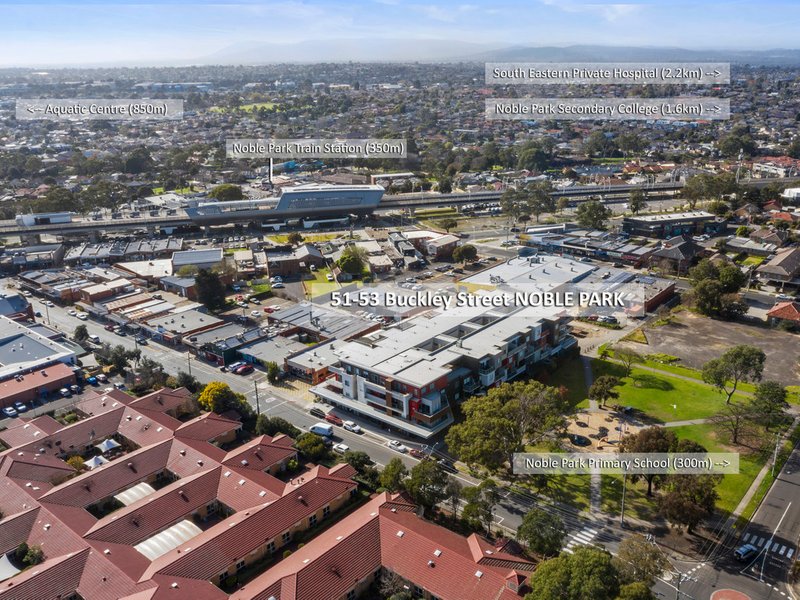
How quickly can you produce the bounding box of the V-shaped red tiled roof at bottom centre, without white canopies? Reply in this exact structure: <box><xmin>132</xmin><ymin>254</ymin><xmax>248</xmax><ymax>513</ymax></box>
<box><xmin>231</xmin><ymin>492</ymin><xmax>534</xmax><ymax>600</ymax></box>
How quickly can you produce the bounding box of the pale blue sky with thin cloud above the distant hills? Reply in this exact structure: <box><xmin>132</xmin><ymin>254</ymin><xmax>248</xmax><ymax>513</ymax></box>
<box><xmin>0</xmin><ymin>0</ymin><xmax>800</xmax><ymax>66</ymax></box>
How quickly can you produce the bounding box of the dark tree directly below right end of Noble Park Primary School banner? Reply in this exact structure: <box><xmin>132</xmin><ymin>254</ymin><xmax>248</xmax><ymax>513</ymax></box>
<box><xmin>660</xmin><ymin>474</ymin><xmax>722</xmax><ymax>533</ymax></box>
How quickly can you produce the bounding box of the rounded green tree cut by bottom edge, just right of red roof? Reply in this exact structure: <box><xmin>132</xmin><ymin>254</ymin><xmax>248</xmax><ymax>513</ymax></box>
<box><xmin>525</xmin><ymin>546</ymin><xmax>619</xmax><ymax>600</ymax></box>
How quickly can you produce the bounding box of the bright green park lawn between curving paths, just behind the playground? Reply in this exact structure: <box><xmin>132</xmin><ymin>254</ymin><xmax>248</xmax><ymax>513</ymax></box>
<box><xmin>592</xmin><ymin>359</ymin><xmax>748</xmax><ymax>423</ymax></box>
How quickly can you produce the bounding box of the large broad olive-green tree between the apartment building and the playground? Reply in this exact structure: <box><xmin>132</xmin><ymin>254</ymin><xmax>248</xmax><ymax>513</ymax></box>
<box><xmin>445</xmin><ymin>380</ymin><xmax>568</xmax><ymax>471</ymax></box>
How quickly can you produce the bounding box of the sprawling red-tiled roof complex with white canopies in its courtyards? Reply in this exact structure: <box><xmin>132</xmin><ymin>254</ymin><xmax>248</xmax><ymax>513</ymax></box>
<box><xmin>0</xmin><ymin>390</ymin><xmax>357</xmax><ymax>600</ymax></box>
